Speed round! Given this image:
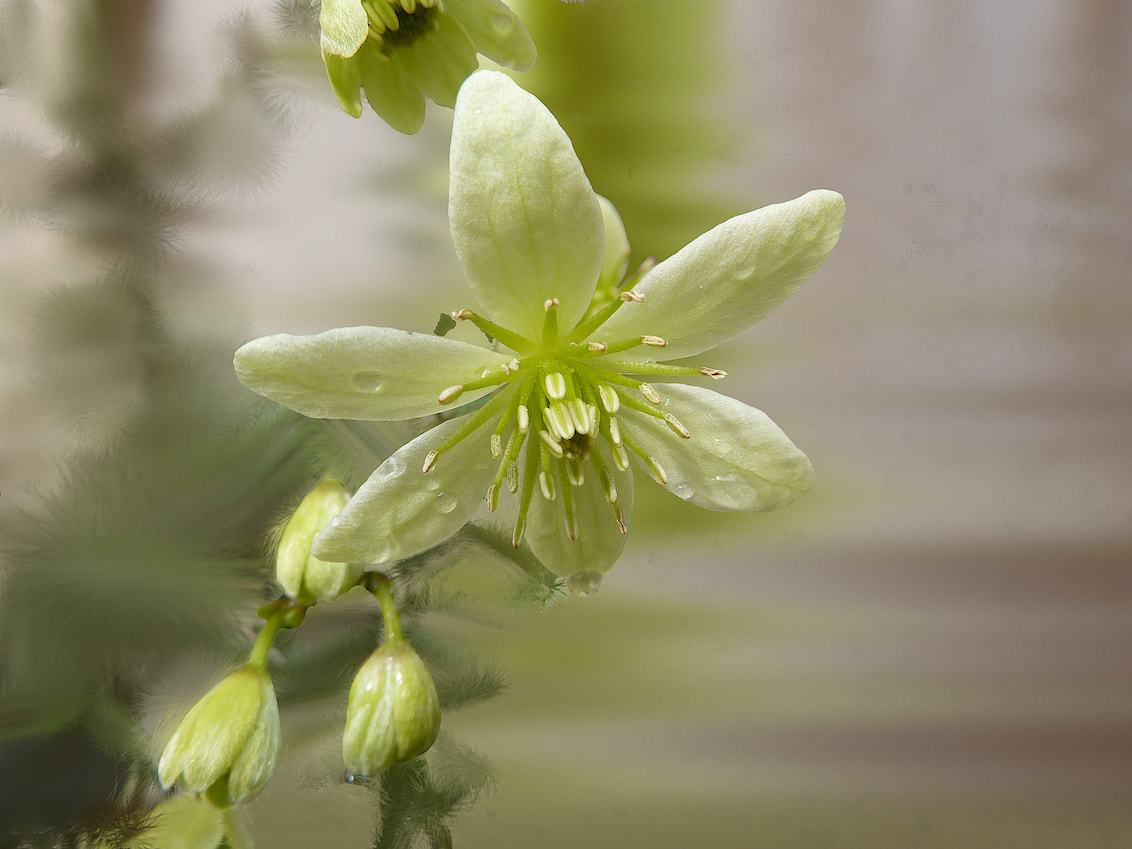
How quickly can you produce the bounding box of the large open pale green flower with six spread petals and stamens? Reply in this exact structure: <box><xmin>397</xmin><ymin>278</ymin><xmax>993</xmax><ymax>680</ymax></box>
<box><xmin>235</xmin><ymin>71</ymin><xmax>844</xmax><ymax>593</ymax></box>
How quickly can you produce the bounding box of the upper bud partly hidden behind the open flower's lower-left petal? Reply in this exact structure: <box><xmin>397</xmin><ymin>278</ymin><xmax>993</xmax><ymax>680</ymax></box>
<box><xmin>275</xmin><ymin>480</ymin><xmax>363</xmax><ymax>602</ymax></box>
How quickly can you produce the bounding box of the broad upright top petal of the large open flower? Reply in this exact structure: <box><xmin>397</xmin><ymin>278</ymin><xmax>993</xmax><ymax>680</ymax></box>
<box><xmin>448</xmin><ymin>71</ymin><xmax>604</xmax><ymax>340</ymax></box>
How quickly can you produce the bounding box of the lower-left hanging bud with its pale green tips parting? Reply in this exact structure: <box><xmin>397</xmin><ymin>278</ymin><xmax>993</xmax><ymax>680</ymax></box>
<box><xmin>157</xmin><ymin>666</ymin><xmax>280</xmax><ymax>808</ymax></box>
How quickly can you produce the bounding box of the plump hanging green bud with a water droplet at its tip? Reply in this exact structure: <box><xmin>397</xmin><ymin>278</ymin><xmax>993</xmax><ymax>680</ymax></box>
<box><xmin>342</xmin><ymin>634</ymin><xmax>440</xmax><ymax>775</ymax></box>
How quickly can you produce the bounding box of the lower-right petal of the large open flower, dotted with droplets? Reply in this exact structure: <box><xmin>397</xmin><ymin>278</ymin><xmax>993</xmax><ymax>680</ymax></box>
<box><xmin>619</xmin><ymin>384</ymin><xmax>814</xmax><ymax>512</ymax></box>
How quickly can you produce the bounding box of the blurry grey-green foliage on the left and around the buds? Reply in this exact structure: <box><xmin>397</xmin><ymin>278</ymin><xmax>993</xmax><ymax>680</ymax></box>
<box><xmin>0</xmin><ymin>0</ymin><xmax>554</xmax><ymax>847</ymax></box>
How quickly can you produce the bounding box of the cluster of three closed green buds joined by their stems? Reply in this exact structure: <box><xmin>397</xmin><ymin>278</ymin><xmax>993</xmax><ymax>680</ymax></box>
<box><xmin>157</xmin><ymin>480</ymin><xmax>440</xmax><ymax>808</ymax></box>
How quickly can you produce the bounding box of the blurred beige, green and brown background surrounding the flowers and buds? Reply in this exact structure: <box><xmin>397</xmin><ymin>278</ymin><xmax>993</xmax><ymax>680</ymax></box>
<box><xmin>0</xmin><ymin>0</ymin><xmax>1132</xmax><ymax>849</ymax></box>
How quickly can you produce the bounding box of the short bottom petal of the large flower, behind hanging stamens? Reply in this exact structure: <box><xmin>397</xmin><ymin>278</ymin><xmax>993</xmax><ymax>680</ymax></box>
<box><xmin>526</xmin><ymin>446</ymin><xmax>633</xmax><ymax>577</ymax></box>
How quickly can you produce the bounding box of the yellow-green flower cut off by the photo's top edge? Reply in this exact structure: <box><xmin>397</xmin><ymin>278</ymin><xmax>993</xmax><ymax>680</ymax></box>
<box><xmin>318</xmin><ymin>0</ymin><xmax>535</xmax><ymax>132</ymax></box>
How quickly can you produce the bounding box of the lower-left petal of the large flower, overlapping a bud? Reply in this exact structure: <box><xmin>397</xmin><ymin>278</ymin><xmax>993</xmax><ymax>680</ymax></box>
<box><xmin>314</xmin><ymin>418</ymin><xmax>497</xmax><ymax>563</ymax></box>
